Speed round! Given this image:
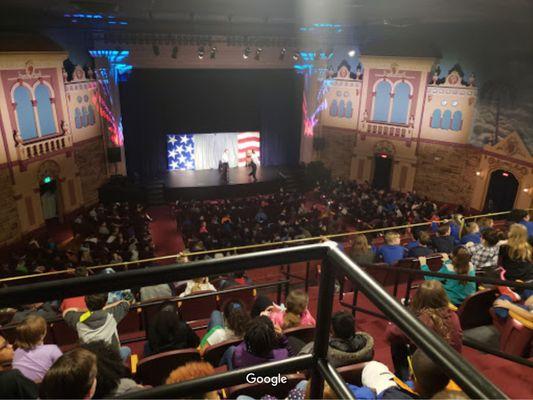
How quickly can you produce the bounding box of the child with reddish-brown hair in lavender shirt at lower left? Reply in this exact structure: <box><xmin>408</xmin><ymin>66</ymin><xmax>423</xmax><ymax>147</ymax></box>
<box><xmin>13</xmin><ymin>314</ymin><xmax>63</xmax><ymax>383</ymax></box>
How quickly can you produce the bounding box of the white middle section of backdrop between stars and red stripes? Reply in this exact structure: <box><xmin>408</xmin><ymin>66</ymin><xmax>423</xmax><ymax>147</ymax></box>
<box><xmin>193</xmin><ymin>133</ymin><xmax>238</xmax><ymax>170</ymax></box>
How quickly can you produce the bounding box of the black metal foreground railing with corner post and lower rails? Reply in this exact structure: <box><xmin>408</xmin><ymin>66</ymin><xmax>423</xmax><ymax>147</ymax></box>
<box><xmin>0</xmin><ymin>242</ymin><xmax>506</xmax><ymax>399</ymax></box>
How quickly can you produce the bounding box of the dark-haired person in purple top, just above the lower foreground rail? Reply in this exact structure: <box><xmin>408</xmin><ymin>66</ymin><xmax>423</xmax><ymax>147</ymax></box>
<box><xmin>229</xmin><ymin>316</ymin><xmax>293</xmax><ymax>369</ymax></box>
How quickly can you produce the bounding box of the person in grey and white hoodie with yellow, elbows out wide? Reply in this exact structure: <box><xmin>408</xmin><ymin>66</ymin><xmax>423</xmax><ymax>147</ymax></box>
<box><xmin>63</xmin><ymin>293</ymin><xmax>131</xmax><ymax>360</ymax></box>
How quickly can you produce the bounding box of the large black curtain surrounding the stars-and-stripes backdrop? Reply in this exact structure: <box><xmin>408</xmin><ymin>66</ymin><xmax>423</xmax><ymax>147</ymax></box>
<box><xmin>120</xmin><ymin>69</ymin><xmax>303</xmax><ymax>178</ymax></box>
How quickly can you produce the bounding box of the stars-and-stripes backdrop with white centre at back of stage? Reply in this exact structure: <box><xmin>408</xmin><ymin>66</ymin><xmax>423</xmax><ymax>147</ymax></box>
<box><xmin>167</xmin><ymin>132</ymin><xmax>261</xmax><ymax>171</ymax></box>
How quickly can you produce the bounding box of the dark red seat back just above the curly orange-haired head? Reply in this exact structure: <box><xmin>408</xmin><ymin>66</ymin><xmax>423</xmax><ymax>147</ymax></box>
<box><xmin>135</xmin><ymin>349</ymin><xmax>200</xmax><ymax>386</ymax></box>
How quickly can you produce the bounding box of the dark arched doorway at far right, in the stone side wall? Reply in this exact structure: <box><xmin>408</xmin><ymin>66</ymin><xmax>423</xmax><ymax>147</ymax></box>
<box><xmin>484</xmin><ymin>169</ymin><xmax>518</xmax><ymax>212</ymax></box>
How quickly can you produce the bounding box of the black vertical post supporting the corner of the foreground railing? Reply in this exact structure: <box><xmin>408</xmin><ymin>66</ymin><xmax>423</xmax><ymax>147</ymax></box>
<box><xmin>310</xmin><ymin>245</ymin><xmax>336</xmax><ymax>399</ymax></box>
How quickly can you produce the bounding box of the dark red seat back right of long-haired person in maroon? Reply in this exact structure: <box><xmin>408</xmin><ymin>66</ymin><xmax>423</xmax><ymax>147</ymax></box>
<box><xmin>457</xmin><ymin>289</ymin><xmax>498</xmax><ymax>330</ymax></box>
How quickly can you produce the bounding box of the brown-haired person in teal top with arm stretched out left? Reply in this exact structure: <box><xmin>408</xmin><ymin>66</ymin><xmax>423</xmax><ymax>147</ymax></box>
<box><xmin>419</xmin><ymin>246</ymin><xmax>476</xmax><ymax>306</ymax></box>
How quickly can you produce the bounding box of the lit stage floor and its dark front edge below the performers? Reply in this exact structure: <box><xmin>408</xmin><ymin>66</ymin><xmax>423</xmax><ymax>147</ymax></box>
<box><xmin>163</xmin><ymin>167</ymin><xmax>294</xmax><ymax>201</ymax></box>
